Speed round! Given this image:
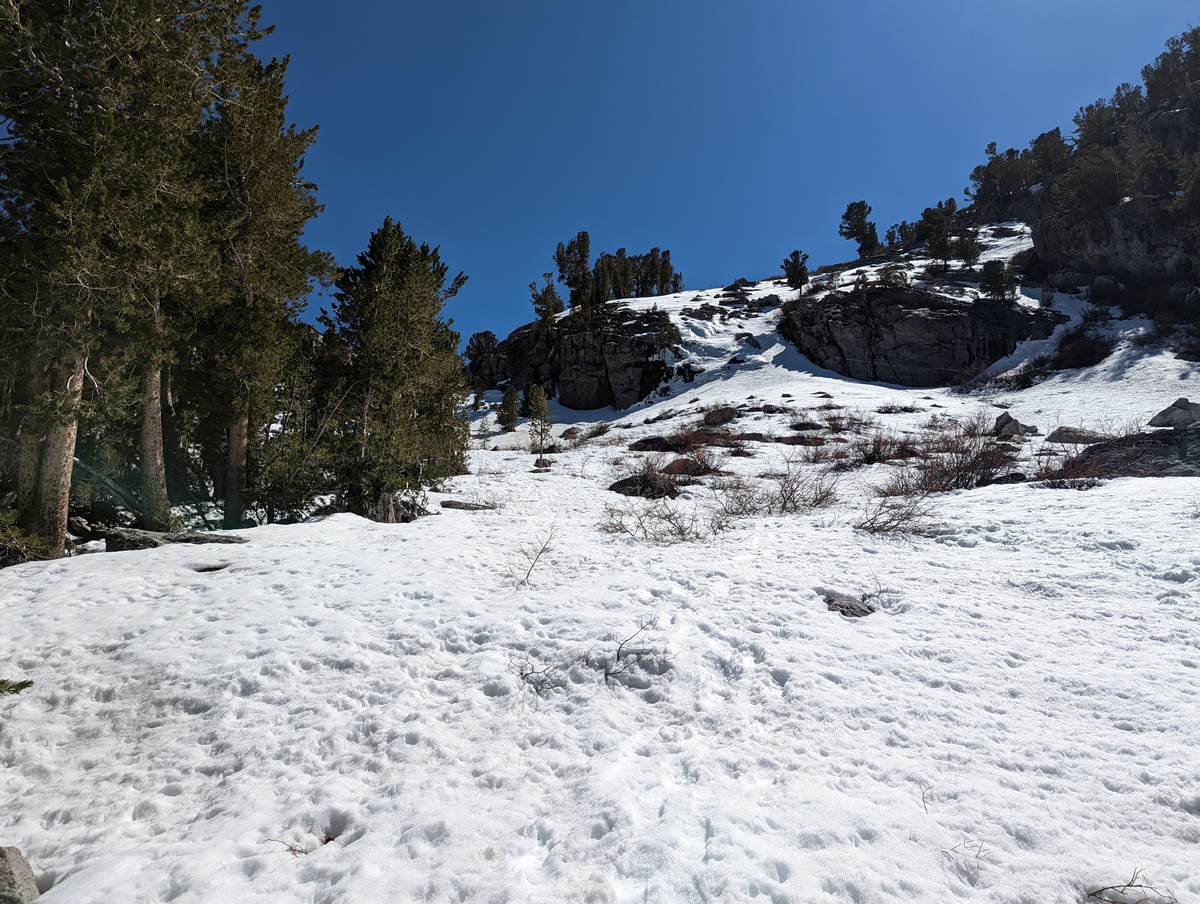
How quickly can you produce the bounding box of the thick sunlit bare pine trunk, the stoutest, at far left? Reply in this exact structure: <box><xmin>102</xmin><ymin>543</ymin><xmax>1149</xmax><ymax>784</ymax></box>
<box><xmin>23</xmin><ymin>353</ymin><xmax>83</xmax><ymax>555</ymax></box>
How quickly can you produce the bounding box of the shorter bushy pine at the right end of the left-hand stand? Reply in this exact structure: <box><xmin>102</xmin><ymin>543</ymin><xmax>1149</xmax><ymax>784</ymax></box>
<box><xmin>320</xmin><ymin>217</ymin><xmax>469</xmax><ymax>514</ymax></box>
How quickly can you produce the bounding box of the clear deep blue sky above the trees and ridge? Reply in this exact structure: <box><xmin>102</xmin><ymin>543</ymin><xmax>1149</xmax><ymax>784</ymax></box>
<box><xmin>259</xmin><ymin>0</ymin><xmax>1200</xmax><ymax>339</ymax></box>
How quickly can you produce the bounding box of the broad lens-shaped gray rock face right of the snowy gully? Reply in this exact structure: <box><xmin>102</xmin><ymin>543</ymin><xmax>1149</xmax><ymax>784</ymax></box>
<box><xmin>779</xmin><ymin>287</ymin><xmax>1061</xmax><ymax>387</ymax></box>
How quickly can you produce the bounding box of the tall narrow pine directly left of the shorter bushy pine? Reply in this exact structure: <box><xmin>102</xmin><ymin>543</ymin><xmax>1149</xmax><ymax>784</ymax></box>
<box><xmin>188</xmin><ymin>52</ymin><xmax>332</xmax><ymax>528</ymax></box>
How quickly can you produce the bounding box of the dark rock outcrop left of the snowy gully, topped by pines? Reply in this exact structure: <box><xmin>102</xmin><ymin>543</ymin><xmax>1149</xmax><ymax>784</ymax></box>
<box><xmin>469</xmin><ymin>307</ymin><xmax>679</xmax><ymax>411</ymax></box>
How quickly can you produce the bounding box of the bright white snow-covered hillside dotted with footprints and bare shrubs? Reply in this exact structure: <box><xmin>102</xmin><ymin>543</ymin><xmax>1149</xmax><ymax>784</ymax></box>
<box><xmin>0</xmin><ymin>220</ymin><xmax>1200</xmax><ymax>904</ymax></box>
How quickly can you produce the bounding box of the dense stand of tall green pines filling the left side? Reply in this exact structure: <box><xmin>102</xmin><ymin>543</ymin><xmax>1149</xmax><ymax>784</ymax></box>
<box><xmin>0</xmin><ymin>0</ymin><xmax>467</xmax><ymax>555</ymax></box>
